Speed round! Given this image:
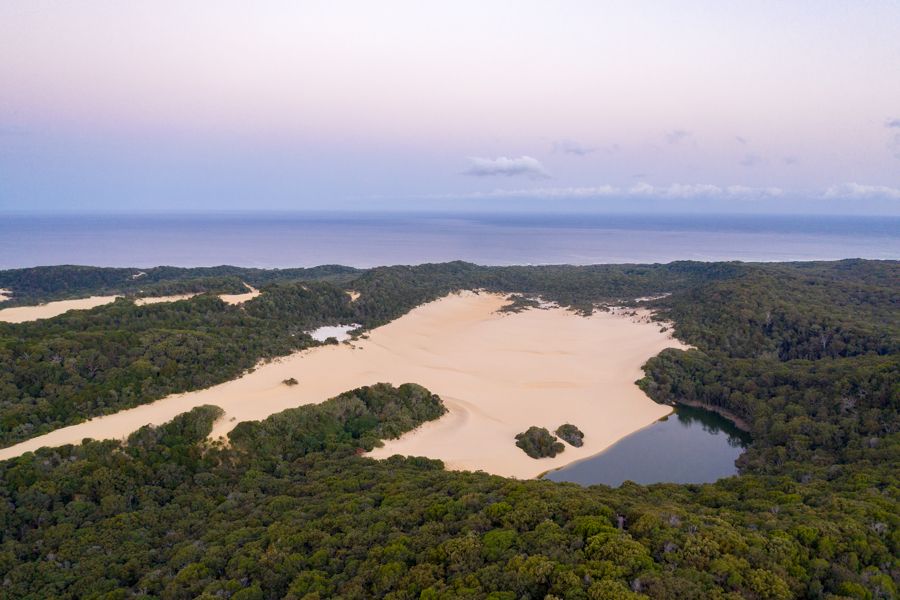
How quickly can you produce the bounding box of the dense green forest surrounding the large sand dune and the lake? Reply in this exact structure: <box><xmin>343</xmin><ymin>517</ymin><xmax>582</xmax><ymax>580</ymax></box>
<box><xmin>0</xmin><ymin>260</ymin><xmax>900</xmax><ymax>600</ymax></box>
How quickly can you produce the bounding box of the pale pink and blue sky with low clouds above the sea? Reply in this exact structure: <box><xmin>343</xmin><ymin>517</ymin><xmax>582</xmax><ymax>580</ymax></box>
<box><xmin>0</xmin><ymin>0</ymin><xmax>900</xmax><ymax>215</ymax></box>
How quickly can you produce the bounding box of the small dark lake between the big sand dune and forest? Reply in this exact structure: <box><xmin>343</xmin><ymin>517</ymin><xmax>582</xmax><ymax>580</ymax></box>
<box><xmin>545</xmin><ymin>406</ymin><xmax>750</xmax><ymax>487</ymax></box>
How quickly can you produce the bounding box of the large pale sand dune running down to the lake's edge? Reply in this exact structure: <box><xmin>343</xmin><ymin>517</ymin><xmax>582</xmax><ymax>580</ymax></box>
<box><xmin>0</xmin><ymin>293</ymin><xmax>679</xmax><ymax>478</ymax></box>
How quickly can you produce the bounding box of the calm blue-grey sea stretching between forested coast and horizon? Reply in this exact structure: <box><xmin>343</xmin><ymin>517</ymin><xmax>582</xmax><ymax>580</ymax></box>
<box><xmin>0</xmin><ymin>213</ymin><xmax>900</xmax><ymax>269</ymax></box>
